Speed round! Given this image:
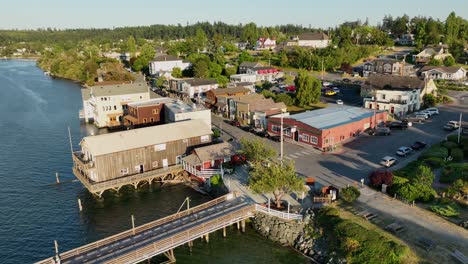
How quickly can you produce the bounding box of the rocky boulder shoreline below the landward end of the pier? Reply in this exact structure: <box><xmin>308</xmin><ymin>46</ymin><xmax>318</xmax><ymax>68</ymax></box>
<box><xmin>251</xmin><ymin>209</ymin><xmax>346</xmax><ymax>264</ymax></box>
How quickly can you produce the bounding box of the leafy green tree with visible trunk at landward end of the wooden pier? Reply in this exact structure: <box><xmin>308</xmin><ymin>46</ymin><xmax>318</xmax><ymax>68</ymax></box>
<box><xmin>249</xmin><ymin>161</ymin><xmax>304</xmax><ymax>208</ymax></box>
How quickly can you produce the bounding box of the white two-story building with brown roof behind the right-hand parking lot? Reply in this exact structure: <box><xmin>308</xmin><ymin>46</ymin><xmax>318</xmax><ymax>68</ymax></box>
<box><xmin>361</xmin><ymin>74</ymin><xmax>437</xmax><ymax>116</ymax></box>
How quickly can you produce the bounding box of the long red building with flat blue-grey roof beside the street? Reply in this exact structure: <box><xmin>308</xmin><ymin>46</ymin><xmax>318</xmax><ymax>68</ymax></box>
<box><xmin>268</xmin><ymin>105</ymin><xmax>387</xmax><ymax>150</ymax></box>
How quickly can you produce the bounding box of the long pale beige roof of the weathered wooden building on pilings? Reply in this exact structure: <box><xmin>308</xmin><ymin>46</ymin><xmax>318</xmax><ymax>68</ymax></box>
<box><xmin>80</xmin><ymin>120</ymin><xmax>212</xmax><ymax>156</ymax></box>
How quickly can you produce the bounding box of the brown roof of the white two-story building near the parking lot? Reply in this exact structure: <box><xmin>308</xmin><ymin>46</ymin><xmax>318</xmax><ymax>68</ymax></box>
<box><xmin>365</xmin><ymin>74</ymin><xmax>425</xmax><ymax>89</ymax></box>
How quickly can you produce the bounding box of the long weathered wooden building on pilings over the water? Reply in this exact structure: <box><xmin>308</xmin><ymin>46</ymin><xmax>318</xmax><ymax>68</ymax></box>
<box><xmin>73</xmin><ymin>120</ymin><xmax>212</xmax><ymax>186</ymax></box>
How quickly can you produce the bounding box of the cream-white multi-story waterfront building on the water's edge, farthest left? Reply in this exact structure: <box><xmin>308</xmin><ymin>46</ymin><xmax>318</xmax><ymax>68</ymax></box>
<box><xmin>82</xmin><ymin>83</ymin><xmax>150</xmax><ymax>128</ymax></box>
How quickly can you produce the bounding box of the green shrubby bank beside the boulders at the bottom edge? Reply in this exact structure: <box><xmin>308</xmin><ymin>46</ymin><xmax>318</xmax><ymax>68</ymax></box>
<box><xmin>318</xmin><ymin>207</ymin><xmax>409</xmax><ymax>264</ymax></box>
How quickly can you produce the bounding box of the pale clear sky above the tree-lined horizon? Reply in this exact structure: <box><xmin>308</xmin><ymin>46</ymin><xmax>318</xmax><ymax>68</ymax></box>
<box><xmin>0</xmin><ymin>0</ymin><xmax>468</xmax><ymax>29</ymax></box>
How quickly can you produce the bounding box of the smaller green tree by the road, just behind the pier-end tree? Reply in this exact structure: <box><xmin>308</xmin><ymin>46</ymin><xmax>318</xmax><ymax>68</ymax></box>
<box><xmin>240</xmin><ymin>138</ymin><xmax>277</xmax><ymax>163</ymax></box>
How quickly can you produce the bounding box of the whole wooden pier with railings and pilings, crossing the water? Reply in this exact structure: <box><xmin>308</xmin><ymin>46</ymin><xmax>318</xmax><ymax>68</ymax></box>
<box><xmin>38</xmin><ymin>193</ymin><xmax>302</xmax><ymax>264</ymax></box>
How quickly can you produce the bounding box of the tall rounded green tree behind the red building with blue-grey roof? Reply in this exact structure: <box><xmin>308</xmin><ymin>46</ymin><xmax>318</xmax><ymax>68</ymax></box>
<box><xmin>294</xmin><ymin>70</ymin><xmax>322</xmax><ymax>106</ymax></box>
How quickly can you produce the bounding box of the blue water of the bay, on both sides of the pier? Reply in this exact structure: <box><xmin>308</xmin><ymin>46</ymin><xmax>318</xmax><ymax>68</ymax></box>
<box><xmin>0</xmin><ymin>60</ymin><xmax>304</xmax><ymax>263</ymax></box>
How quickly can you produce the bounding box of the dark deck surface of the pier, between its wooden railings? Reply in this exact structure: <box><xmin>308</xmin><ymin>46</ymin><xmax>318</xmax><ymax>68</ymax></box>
<box><xmin>62</xmin><ymin>198</ymin><xmax>250</xmax><ymax>264</ymax></box>
